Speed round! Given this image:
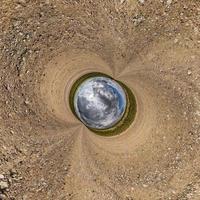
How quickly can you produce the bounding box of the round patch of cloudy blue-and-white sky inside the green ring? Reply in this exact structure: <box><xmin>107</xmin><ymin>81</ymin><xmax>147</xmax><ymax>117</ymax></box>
<box><xmin>74</xmin><ymin>76</ymin><xmax>127</xmax><ymax>129</ymax></box>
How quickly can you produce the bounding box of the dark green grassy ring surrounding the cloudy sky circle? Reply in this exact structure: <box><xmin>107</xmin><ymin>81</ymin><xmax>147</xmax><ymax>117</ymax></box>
<box><xmin>69</xmin><ymin>72</ymin><xmax>137</xmax><ymax>136</ymax></box>
